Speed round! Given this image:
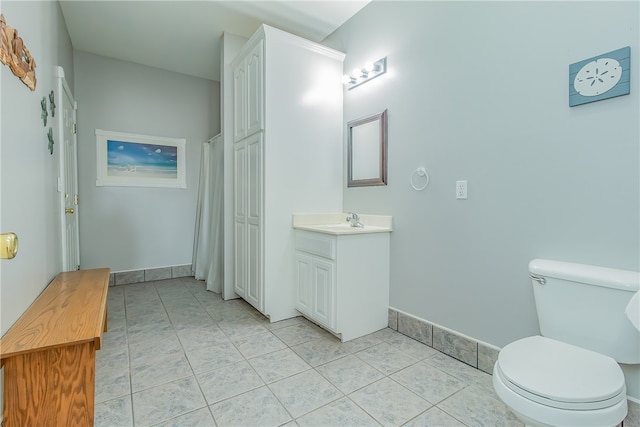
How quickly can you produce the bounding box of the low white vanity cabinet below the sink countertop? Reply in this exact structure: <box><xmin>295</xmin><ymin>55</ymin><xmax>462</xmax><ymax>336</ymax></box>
<box><xmin>295</xmin><ymin>229</ymin><xmax>390</xmax><ymax>341</ymax></box>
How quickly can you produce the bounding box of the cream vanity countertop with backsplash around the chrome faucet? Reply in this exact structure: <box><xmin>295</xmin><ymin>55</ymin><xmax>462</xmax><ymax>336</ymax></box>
<box><xmin>293</xmin><ymin>212</ymin><xmax>392</xmax><ymax>235</ymax></box>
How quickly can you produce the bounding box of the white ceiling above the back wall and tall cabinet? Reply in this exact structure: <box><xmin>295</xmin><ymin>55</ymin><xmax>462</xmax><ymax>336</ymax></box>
<box><xmin>60</xmin><ymin>0</ymin><xmax>370</xmax><ymax>80</ymax></box>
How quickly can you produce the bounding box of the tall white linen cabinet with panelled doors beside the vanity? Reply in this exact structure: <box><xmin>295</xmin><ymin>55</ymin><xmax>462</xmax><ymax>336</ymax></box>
<box><xmin>231</xmin><ymin>25</ymin><xmax>344</xmax><ymax>322</ymax></box>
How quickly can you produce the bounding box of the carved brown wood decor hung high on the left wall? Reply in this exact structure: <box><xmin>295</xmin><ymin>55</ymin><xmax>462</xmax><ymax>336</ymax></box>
<box><xmin>0</xmin><ymin>14</ymin><xmax>36</xmax><ymax>90</ymax></box>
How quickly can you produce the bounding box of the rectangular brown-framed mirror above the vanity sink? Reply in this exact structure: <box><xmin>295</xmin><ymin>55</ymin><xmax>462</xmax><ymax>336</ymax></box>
<box><xmin>347</xmin><ymin>110</ymin><xmax>387</xmax><ymax>187</ymax></box>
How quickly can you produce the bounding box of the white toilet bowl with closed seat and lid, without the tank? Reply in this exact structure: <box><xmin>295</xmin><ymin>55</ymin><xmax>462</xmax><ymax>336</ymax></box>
<box><xmin>493</xmin><ymin>336</ymin><xmax>627</xmax><ymax>427</ymax></box>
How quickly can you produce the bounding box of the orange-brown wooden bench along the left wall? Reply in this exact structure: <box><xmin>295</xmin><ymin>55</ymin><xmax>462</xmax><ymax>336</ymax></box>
<box><xmin>0</xmin><ymin>268</ymin><xmax>109</xmax><ymax>427</ymax></box>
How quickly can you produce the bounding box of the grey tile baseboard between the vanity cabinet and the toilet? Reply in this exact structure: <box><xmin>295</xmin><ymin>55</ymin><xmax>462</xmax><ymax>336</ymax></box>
<box><xmin>389</xmin><ymin>307</ymin><xmax>500</xmax><ymax>374</ymax></box>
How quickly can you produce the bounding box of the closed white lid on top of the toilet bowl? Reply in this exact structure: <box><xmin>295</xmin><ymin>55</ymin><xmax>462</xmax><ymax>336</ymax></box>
<box><xmin>497</xmin><ymin>336</ymin><xmax>626</xmax><ymax>409</ymax></box>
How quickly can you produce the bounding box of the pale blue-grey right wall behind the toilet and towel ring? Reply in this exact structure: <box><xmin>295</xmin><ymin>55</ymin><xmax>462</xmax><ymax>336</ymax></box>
<box><xmin>324</xmin><ymin>2</ymin><xmax>640</xmax><ymax>398</ymax></box>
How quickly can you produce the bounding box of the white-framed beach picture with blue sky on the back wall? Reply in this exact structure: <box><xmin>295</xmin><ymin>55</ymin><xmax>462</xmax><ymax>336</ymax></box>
<box><xmin>96</xmin><ymin>129</ymin><xmax>187</xmax><ymax>188</ymax></box>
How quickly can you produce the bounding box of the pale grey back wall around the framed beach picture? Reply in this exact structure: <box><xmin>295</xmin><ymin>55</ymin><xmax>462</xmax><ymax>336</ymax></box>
<box><xmin>74</xmin><ymin>51</ymin><xmax>220</xmax><ymax>271</ymax></box>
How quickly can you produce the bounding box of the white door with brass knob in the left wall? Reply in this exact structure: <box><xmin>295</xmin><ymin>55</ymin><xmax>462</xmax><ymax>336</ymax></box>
<box><xmin>56</xmin><ymin>67</ymin><xmax>80</xmax><ymax>271</ymax></box>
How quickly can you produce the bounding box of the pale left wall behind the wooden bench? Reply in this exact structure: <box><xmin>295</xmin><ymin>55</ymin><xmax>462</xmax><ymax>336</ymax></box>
<box><xmin>0</xmin><ymin>0</ymin><xmax>73</xmax><ymax>416</ymax></box>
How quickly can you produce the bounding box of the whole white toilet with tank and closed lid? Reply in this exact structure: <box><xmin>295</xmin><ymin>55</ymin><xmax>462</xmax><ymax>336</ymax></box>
<box><xmin>493</xmin><ymin>259</ymin><xmax>640</xmax><ymax>427</ymax></box>
